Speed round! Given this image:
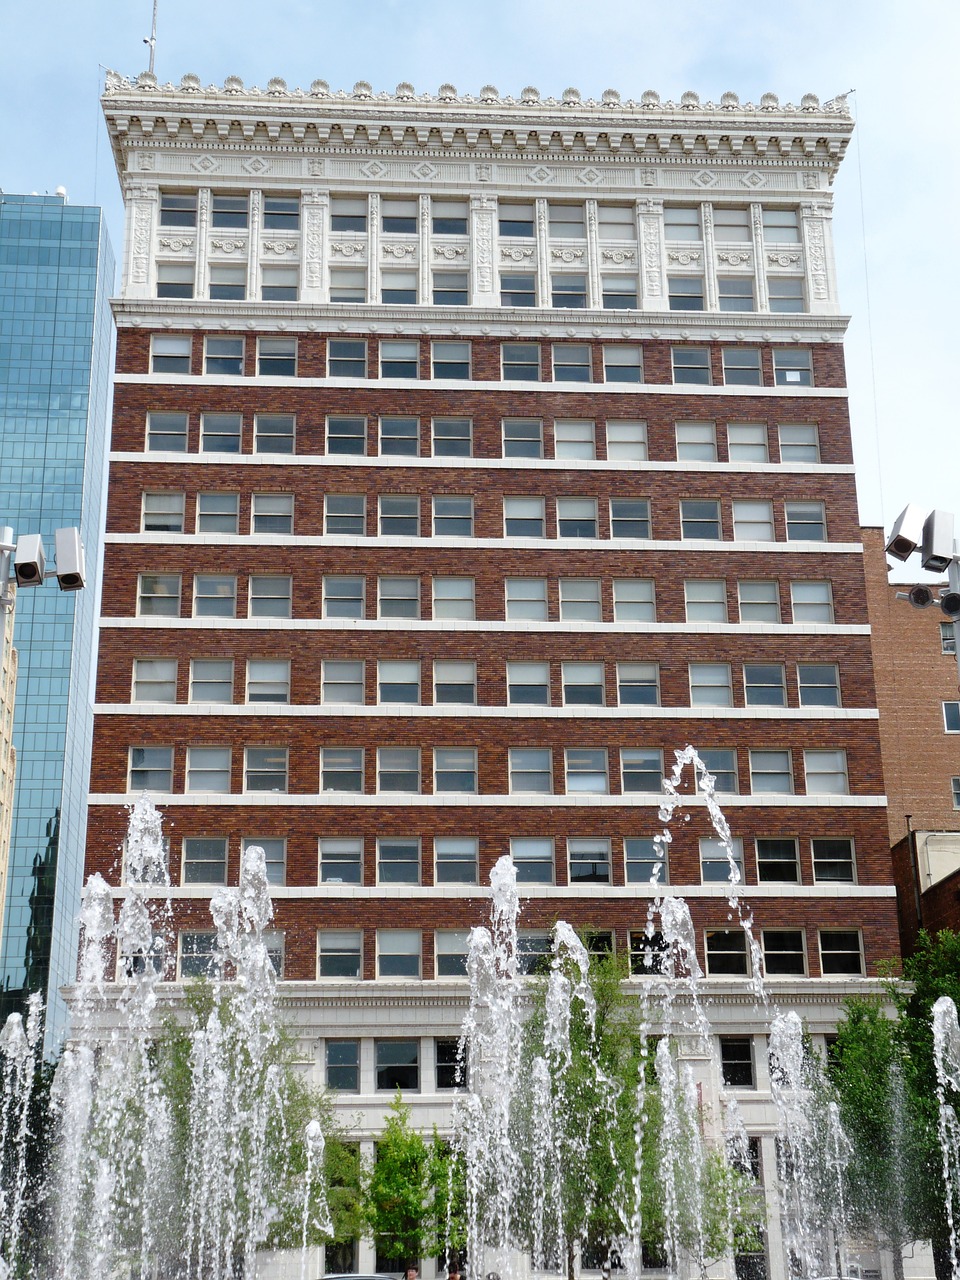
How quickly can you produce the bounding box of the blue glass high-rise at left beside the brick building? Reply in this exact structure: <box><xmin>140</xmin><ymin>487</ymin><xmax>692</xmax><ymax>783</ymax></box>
<box><xmin>0</xmin><ymin>195</ymin><xmax>114</xmax><ymax>1048</ymax></box>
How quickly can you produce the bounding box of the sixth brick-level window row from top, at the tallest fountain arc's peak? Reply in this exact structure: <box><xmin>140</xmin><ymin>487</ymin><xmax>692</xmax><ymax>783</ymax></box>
<box><xmin>128</xmin><ymin>746</ymin><xmax>850</xmax><ymax>795</ymax></box>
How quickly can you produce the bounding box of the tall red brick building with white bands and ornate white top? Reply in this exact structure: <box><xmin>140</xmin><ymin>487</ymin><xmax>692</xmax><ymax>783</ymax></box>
<box><xmin>87</xmin><ymin>74</ymin><xmax>897</xmax><ymax>1274</ymax></box>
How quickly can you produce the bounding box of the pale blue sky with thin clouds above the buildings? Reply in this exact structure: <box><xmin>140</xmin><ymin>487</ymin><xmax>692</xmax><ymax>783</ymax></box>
<box><xmin>0</xmin><ymin>0</ymin><xmax>960</xmax><ymax>560</ymax></box>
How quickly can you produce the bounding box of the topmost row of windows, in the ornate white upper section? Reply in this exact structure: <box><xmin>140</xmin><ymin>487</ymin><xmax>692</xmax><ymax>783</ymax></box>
<box><xmin>160</xmin><ymin>191</ymin><xmax>800</xmax><ymax>244</ymax></box>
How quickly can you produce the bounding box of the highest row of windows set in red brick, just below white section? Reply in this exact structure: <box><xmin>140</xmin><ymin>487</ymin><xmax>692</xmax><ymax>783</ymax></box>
<box><xmin>150</xmin><ymin>332</ymin><xmax>813</xmax><ymax>387</ymax></box>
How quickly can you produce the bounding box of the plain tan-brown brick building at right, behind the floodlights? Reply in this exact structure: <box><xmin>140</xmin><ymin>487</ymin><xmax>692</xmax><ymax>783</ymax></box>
<box><xmin>863</xmin><ymin>529</ymin><xmax>960</xmax><ymax>950</ymax></box>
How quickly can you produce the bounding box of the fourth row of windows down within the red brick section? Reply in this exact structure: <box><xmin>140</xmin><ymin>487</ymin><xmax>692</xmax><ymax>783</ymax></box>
<box><xmin>137</xmin><ymin>573</ymin><xmax>833</xmax><ymax>623</ymax></box>
